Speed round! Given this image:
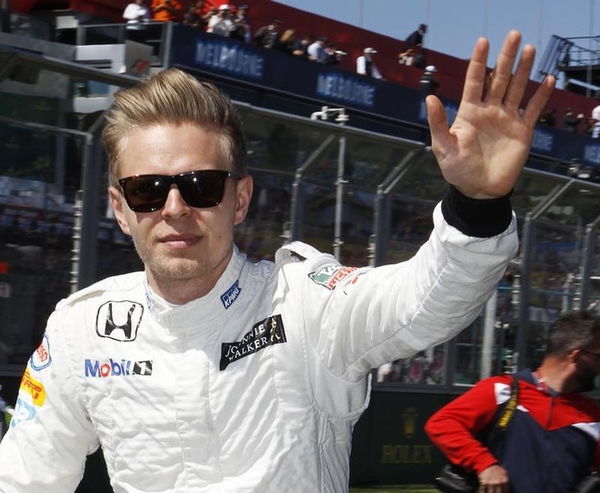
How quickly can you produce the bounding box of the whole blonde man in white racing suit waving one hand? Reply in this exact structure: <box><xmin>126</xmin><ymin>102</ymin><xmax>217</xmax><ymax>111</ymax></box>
<box><xmin>0</xmin><ymin>31</ymin><xmax>554</xmax><ymax>493</ymax></box>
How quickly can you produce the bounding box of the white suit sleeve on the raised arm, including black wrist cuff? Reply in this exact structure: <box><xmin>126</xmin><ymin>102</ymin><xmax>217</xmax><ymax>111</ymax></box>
<box><xmin>301</xmin><ymin>186</ymin><xmax>518</xmax><ymax>382</ymax></box>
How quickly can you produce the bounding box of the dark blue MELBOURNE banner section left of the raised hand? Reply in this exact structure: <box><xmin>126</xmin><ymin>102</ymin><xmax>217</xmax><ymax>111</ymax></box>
<box><xmin>170</xmin><ymin>25</ymin><xmax>422</xmax><ymax>121</ymax></box>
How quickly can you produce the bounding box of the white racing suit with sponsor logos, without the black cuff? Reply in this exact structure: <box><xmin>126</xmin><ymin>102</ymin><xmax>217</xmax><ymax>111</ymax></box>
<box><xmin>0</xmin><ymin>198</ymin><xmax>517</xmax><ymax>493</ymax></box>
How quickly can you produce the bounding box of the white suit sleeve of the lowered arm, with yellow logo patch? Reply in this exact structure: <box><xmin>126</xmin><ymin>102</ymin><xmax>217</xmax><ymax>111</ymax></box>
<box><xmin>0</xmin><ymin>312</ymin><xmax>99</xmax><ymax>493</ymax></box>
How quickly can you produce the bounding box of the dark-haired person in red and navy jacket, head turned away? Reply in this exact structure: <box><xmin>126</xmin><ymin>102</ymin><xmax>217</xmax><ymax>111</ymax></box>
<box><xmin>425</xmin><ymin>311</ymin><xmax>600</xmax><ymax>493</ymax></box>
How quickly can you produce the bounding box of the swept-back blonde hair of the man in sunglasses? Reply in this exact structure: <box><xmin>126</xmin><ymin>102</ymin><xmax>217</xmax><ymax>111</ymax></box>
<box><xmin>102</xmin><ymin>68</ymin><xmax>246</xmax><ymax>186</ymax></box>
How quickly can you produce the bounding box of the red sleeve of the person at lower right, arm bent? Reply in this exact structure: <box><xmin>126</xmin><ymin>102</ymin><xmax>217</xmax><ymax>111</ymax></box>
<box><xmin>425</xmin><ymin>377</ymin><xmax>500</xmax><ymax>473</ymax></box>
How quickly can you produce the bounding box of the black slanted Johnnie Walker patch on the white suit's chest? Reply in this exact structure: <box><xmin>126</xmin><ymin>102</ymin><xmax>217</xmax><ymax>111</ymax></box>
<box><xmin>219</xmin><ymin>315</ymin><xmax>287</xmax><ymax>371</ymax></box>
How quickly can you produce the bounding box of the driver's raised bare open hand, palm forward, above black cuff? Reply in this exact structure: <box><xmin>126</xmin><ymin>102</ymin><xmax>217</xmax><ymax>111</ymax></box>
<box><xmin>427</xmin><ymin>31</ymin><xmax>555</xmax><ymax>199</ymax></box>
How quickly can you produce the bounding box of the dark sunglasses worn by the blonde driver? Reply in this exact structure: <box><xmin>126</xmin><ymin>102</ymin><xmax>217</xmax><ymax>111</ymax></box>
<box><xmin>119</xmin><ymin>169</ymin><xmax>240</xmax><ymax>212</ymax></box>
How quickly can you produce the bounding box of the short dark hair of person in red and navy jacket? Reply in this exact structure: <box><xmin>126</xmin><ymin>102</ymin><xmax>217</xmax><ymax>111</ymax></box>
<box><xmin>546</xmin><ymin>310</ymin><xmax>600</xmax><ymax>356</ymax></box>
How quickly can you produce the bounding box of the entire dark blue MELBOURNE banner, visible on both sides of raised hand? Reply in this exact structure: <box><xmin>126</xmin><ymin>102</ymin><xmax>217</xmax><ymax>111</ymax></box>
<box><xmin>170</xmin><ymin>24</ymin><xmax>600</xmax><ymax>171</ymax></box>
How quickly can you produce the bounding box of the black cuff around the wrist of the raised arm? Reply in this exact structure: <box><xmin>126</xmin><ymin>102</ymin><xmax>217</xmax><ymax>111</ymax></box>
<box><xmin>442</xmin><ymin>185</ymin><xmax>512</xmax><ymax>238</ymax></box>
